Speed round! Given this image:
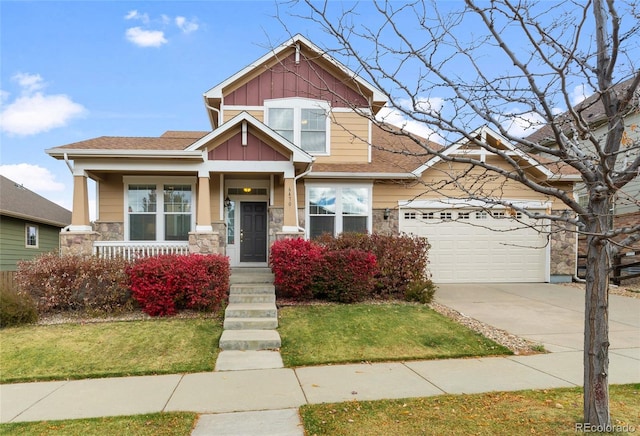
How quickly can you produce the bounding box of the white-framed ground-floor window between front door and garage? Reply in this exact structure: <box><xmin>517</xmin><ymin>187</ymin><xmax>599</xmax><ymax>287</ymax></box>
<box><xmin>306</xmin><ymin>183</ymin><xmax>372</xmax><ymax>239</ymax></box>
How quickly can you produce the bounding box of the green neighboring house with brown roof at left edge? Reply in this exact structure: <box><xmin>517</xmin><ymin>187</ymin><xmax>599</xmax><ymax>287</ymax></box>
<box><xmin>0</xmin><ymin>176</ymin><xmax>71</xmax><ymax>271</ymax></box>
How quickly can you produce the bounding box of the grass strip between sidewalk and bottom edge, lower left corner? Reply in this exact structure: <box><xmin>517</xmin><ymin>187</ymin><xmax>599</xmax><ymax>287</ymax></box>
<box><xmin>0</xmin><ymin>413</ymin><xmax>197</xmax><ymax>436</ymax></box>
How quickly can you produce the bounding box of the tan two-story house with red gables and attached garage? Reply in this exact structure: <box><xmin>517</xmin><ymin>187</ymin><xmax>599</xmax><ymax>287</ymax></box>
<box><xmin>47</xmin><ymin>35</ymin><xmax>575</xmax><ymax>282</ymax></box>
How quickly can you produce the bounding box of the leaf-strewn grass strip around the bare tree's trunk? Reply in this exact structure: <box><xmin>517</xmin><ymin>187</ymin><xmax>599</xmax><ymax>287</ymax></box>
<box><xmin>300</xmin><ymin>384</ymin><xmax>640</xmax><ymax>436</ymax></box>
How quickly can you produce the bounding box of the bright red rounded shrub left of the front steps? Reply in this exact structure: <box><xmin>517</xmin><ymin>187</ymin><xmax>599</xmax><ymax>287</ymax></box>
<box><xmin>127</xmin><ymin>254</ymin><xmax>230</xmax><ymax>316</ymax></box>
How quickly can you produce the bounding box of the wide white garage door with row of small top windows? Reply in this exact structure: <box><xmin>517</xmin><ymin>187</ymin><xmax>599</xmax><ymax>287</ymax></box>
<box><xmin>400</xmin><ymin>209</ymin><xmax>548</xmax><ymax>283</ymax></box>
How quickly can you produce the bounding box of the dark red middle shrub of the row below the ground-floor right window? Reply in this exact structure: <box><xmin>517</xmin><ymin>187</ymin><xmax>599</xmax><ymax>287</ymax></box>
<box><xmin>313</xmin><ymin>248</ymin><xmax>377</xmax><ymax>303</ymax></box>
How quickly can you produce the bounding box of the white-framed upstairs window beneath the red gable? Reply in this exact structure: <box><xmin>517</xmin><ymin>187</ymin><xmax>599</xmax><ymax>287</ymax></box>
<box><xmin>264</xmin><ymin>97</ymin><xmax>331</xmax><ymax>155</ymax></box>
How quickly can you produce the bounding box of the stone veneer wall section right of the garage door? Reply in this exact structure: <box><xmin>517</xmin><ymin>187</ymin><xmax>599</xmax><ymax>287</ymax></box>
<box><xmin>550</xmin><ymin>215</ymin><xmax>578</xmax><ymax>283</ymax></box>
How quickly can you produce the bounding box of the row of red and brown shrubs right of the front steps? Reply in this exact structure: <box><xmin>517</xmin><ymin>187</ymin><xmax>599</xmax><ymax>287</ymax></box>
<box><xmin>270</xmin><ymin>233</ymin><xmax>436</xmax><ymax>304</ymax></box>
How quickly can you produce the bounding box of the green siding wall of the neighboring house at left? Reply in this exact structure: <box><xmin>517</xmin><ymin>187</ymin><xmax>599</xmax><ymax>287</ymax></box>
<box><xmin>0</xmin><ymin>216</ymin><xmax>60</xmax><ymax>271</ymax></box>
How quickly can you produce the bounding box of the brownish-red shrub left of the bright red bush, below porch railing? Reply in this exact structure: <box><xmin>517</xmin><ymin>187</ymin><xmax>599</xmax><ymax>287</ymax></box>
<box><xmin>16</xmin><ymin>253</ymin><xmax>133</xmax><ymax>314</ymax></box>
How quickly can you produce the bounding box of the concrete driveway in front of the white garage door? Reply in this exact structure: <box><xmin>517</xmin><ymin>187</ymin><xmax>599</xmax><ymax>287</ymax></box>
<box><xmin>435</xmin><ymin>283</ymin><xmax>640</xmax><ymax>354</ymax></box>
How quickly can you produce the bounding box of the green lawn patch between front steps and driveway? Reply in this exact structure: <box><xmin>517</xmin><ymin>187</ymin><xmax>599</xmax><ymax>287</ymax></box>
<box><xmin>278</xmin><ymin>303</ymin><xmax>511</xmax><ymax>367</ymax></box>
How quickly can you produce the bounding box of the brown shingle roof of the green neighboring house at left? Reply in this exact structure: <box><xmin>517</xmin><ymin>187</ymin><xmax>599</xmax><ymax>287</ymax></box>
<box><xmin>0</xmin><ymin>176</ymin><xmax>71</xmax><ymax>227</ymax></box>
